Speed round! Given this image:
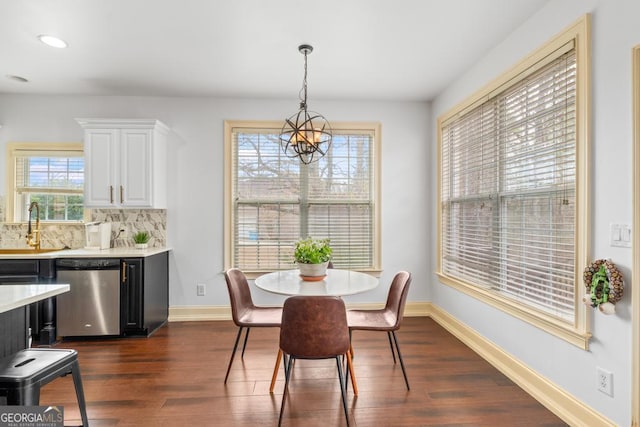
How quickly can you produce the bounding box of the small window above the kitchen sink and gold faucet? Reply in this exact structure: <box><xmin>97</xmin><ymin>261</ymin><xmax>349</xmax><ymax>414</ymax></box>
<box><xmin>8</xmin><ymin>143</ymin><xmax>84</xmax><ymax>222</ymax></box>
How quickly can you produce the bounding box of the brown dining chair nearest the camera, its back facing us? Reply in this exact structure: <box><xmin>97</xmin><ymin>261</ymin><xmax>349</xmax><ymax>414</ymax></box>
<box><xmin>278</xmin><ymin>296</ymin><xmax>353</xmax><ymax>425</ymax></box>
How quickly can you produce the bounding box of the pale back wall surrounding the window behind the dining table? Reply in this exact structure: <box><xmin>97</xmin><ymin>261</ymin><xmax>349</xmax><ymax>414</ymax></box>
<box><xmin>0</xmin><ymin>95</ymin><xmax>431</xmax><ymax>306</ymax></box>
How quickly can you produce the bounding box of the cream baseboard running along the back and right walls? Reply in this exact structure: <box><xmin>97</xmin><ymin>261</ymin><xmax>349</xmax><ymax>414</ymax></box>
<box><xmin>169</xmin><ymin>302</ymin><xmax>615</xmax><ymax>427</ymax></box>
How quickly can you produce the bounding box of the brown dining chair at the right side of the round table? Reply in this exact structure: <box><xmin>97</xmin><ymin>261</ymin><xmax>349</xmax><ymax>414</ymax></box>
<box><xmin>347</xmin><ymin>271</ymin><xmax>411</xmax><ymax>390</ymax></box>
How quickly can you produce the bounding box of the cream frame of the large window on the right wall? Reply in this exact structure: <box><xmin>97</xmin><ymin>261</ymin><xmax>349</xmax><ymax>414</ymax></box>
<box><xmin>436</xmin><ymin>14</ymin><xmax>591</xmax><ymax>349</ymax></box>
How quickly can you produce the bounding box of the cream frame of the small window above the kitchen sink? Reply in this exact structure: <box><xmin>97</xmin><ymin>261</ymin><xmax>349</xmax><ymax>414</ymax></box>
<box><xmin>5</xmin><ymin>142</ymin><xmax>89</xmax><ymax>224</ymax></box>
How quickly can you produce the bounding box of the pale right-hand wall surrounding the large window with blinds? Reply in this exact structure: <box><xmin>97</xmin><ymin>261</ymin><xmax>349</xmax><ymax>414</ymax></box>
<box><xmin>430</xmin><ymin>0</ymin><xmax>640</xmax><ymax>426</ymax></box>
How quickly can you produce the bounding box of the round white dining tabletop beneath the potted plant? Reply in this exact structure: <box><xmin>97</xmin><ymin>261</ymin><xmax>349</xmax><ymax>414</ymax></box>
<box><xmin>255</xmin><ymin>268</ymin><xmax>378</xmax><ymax>297</ymax></box>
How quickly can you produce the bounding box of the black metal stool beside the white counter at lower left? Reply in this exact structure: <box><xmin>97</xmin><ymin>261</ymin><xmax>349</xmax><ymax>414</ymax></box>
<box><xmin>0</xmin><ymin>348</ymin><xmax>89</xmax><ymax>426</ymax></box>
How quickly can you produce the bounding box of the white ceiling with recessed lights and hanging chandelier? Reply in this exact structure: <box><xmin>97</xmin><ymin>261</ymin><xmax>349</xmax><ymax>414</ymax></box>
<box><xmin>0</xmin><ymin>0</ymin><xmax>548</xmax><ymax>101</ymax></box>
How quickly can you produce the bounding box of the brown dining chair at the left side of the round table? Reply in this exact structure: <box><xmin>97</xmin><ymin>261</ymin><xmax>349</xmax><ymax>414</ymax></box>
<box><xmin>224</xmin><ymin>268</ymin><xmax>282</xmax><ymax>384</ymax></box>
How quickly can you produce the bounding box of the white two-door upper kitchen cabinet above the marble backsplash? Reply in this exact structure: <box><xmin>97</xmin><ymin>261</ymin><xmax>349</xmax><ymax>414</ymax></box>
<box><xmin>76</xmin><ymin>119</ymin><xmax>169</xmax><ymax>208</ymax></box>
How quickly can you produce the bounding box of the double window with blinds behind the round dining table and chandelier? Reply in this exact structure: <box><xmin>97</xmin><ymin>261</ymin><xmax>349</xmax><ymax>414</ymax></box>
<box><xmin>225</xmin><ymin>122</ymin><xmax>380</xmax><ymax>272</ymax></box>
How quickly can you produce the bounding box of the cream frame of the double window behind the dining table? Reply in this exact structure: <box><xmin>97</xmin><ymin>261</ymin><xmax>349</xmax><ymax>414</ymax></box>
<box><xmin>224</xmin><ymin>120</ymin><xmax>382</xmax><ymax>278</ymax></box>
